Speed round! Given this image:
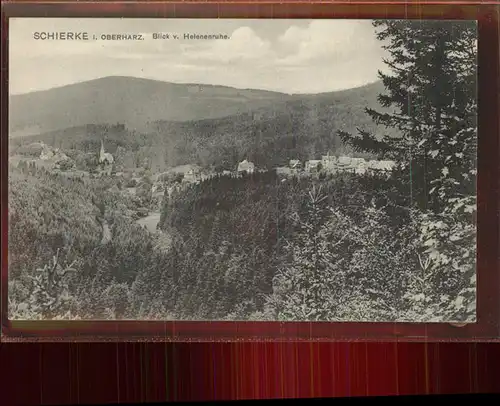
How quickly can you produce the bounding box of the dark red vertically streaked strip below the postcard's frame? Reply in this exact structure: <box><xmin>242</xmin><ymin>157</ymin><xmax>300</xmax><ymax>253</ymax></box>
<box><xmin>0</xmin><ymin>343</ymin><xmax>500</xmax><ymax>406</ymax></box>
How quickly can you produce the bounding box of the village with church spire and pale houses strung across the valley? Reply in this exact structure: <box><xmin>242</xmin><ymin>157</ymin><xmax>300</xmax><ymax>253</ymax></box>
<box><xmin>9</xmin><ymin>139</ymin><xmax>394</xmax><ymax>231</ymax></box>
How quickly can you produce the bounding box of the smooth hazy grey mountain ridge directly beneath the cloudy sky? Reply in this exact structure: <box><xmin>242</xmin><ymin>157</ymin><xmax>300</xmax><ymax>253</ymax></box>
<box><xmin>9</xmin><ymin>76</ymin><xmax>381</xmax><ymax>137</ymax></box>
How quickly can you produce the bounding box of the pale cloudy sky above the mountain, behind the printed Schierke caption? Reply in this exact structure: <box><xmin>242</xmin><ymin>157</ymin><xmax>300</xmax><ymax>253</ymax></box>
<box><xmin>9</xmin><ymin>18</ymin><xmax>386</xmax><ymax>94</ymax></box>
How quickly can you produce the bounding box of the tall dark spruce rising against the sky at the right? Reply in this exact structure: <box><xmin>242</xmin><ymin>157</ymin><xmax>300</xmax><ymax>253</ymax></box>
<box><xmin>340</xmin><ymin>20</ymin><xmax>477</xmax><ymax>210</ymax></box>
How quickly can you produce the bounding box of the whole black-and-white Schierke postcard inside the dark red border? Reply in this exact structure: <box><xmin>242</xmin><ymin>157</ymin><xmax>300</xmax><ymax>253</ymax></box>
<box><xmin>8</xmin><ymin>18</ymin><xmax>478</xmax><ymax>323</ymax></box>
